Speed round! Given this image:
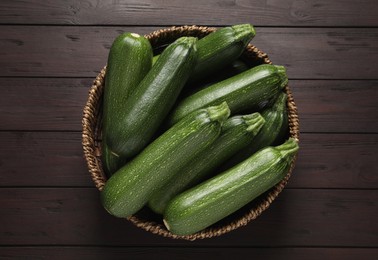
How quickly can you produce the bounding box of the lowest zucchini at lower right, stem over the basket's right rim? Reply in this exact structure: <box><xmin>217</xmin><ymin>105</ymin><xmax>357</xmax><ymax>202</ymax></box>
<box><xmin>164</xmin><ymin>138</ymin><xmax>299</xmax><ymax>235</ymax></box>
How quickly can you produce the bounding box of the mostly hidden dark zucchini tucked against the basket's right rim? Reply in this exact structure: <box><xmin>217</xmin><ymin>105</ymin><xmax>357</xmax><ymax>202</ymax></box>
<box><xmin>221</xmin><ymin>92</ymin><xmax>289</xmax><ymax>169</ymax></box>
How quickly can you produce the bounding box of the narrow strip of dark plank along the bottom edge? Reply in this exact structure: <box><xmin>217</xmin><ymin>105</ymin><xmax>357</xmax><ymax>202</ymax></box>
<box><xmin>0</xmin><ymin>246</ymin><xmax>378</xmax><ymax>260</ymax></box>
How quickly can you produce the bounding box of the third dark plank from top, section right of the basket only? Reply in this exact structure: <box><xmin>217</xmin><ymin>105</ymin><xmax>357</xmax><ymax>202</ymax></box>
<box><xmin>289</xmin><ymin>80</ymin><xmax>378</xmax><ymax>133</ymax></box>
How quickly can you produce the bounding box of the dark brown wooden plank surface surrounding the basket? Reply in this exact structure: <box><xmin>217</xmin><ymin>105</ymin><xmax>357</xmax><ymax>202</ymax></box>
<box><xmin>0</xmin><ymin>0</ymin><xmax>378</xmax><ymax>259</ymax></box>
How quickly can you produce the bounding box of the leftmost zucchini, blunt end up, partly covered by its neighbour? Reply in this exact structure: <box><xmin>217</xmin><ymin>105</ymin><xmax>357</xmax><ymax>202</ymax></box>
<box><xmin>102</xmin><ymin>33</ymin><xmax>153</xmax><ymax>174</ymax></box>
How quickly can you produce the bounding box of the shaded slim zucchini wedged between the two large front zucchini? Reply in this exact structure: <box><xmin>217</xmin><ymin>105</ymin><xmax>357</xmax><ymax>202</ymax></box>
<box><xmin>148</xmin><ymin>113</ymin><xmax>264</xmax><ymax>214</ymax></box>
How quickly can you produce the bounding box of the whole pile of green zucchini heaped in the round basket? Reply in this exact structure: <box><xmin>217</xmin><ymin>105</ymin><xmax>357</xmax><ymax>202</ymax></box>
<box><xmin>101</xmin><ymin>24</ymin><xmax>298</xmax><ymax>235</ymax></box>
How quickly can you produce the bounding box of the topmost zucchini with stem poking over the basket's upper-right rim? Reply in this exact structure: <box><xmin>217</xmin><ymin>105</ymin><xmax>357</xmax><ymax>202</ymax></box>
<box><xmin>154</xmin><ymin>24</ymin><xmax>256</xmax><ymax>81</ymax></box>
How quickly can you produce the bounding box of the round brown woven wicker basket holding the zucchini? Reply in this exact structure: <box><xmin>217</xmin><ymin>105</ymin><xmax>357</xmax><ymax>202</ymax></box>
<box><xmin>82</xmin><ymin>25</ymin><xmax>299</xmax><ymax>240</ymax></box>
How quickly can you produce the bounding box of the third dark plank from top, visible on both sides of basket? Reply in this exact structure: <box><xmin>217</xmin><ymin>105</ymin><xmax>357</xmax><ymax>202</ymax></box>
<box><xmin>0</xmin><ymin>78</ymin><xmax>378</xmax><ymax>133</ymax></box>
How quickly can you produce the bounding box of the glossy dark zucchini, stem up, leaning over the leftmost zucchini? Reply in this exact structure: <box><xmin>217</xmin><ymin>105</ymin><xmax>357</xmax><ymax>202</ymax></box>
<box><xmin>106</xmin><ymin>37</ymin><xmax>197</xmax><ymax>158</ymax></box>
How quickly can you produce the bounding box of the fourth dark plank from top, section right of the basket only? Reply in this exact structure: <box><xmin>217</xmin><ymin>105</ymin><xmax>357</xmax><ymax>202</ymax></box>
<box><xmin>288</xmin><ymin>134</ymin><xmax>378</xmax><ymax>189</ymax></box>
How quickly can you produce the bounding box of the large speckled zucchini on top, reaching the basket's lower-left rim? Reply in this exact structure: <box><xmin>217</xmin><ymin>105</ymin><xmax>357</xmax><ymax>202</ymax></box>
<box><xmin>100</xmin><ymin>103</ymin><xmax>230</xmax><ymax>217</ymax></box>
